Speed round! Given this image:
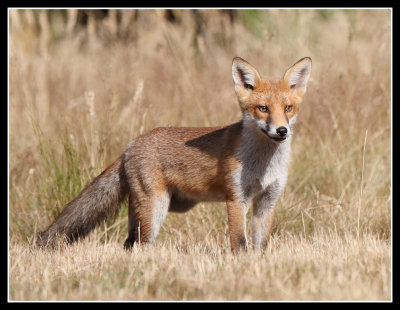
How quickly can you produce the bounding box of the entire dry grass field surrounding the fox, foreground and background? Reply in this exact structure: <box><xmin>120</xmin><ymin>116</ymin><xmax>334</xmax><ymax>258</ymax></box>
<box><xmin>8</xmin><ymin>9</ymin><xmax>392</xmax><ymax>301</ymax></box>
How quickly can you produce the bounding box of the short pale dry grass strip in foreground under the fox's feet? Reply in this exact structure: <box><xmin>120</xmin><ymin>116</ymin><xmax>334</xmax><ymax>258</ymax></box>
<box><xmin>10</xmin><ymin>232</ymin><xmax>391</xmax><ymax>301</ymax></box>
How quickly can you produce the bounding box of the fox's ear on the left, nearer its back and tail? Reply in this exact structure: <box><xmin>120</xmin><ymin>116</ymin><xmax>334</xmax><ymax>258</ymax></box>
<box><xmin>232</xmin><ymin>57</ymin><xmax>261</xmax><ymax>97</ymax></box>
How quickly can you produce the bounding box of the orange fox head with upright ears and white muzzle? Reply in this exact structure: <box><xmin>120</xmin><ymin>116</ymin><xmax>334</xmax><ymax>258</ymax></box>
<box><xmin>232</xmin><ymin>57</ymin><xmax>311</xmax><ymax>143</ymax></box>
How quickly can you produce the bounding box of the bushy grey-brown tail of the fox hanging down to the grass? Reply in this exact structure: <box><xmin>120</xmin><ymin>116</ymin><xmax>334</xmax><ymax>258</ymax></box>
<box><xmin>37</xmin><ymin>155</ymin><xmax>128</xmax><ymax>247</ymax></box>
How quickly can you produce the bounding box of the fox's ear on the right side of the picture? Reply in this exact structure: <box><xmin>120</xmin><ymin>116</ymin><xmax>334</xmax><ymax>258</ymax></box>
<box><xmin>283</xmin><ymin>57</ymin><xmax>311</xmax><ymax>95</ymax></box>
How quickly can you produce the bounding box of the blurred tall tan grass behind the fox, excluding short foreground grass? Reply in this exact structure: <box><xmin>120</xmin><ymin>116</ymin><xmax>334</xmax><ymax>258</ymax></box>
<box><xmin>9</xmin><ymin>9</ymin><xmax>392</xmax><ymax>247</ymax></box>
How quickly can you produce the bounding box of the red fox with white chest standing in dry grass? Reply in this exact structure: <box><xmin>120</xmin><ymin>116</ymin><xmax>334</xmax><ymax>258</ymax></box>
<box><xmin>37</xmin><ymin>57</ymin><xmax>311</xmax><ymax>253</ymax></box>
